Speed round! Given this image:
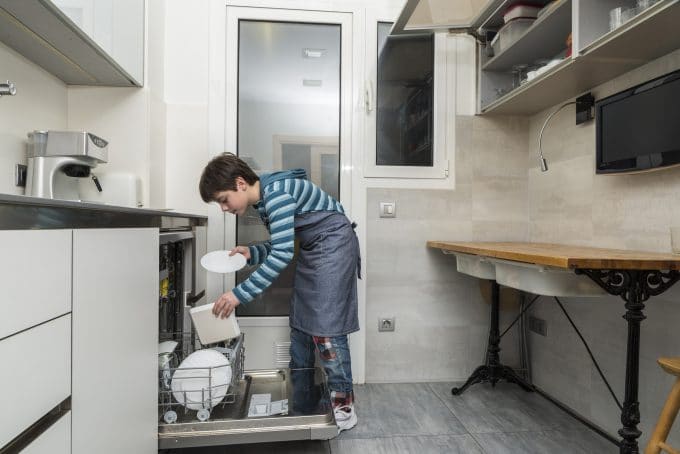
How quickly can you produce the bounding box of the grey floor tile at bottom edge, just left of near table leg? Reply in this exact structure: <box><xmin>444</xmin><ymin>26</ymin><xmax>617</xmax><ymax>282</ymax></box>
<box><xmin>473</xmin><ymin>429</ymin><xmax>619</xmax><ymax>454</ymax></box>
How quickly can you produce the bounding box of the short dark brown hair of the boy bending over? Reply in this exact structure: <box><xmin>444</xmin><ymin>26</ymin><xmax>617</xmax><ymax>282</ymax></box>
<box><xmin>198</xmin><ymin>153</ymin><xmax>260</xmax><ymax>203</ymax></box>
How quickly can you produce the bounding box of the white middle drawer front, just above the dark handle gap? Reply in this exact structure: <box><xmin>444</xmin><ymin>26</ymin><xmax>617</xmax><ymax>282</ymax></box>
<box><xmin>0</xmin><ymin>314</ymin><xmax>71</xmax><ymax>447</ymax></box>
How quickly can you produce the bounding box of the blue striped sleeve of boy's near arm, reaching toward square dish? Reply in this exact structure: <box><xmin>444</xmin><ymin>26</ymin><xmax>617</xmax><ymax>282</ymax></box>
<box><xmin>233</xmin><ymin>191</ymin><xmax>295</xmax><ymax>303</ymax></box>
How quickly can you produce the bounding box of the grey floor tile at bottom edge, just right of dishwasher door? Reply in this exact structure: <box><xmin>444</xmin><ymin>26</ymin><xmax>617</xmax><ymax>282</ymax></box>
<box><xmin>330</xmin><ymin>435</ymin><xmax>485</xmax><ymax>454</ymax></box>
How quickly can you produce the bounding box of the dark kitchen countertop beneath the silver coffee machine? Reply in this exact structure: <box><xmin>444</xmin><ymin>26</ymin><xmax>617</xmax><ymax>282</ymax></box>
<box><xmin>0</xmin><ymin>194</ymin><xmax>208</xmax><ymax>230</ymax></box>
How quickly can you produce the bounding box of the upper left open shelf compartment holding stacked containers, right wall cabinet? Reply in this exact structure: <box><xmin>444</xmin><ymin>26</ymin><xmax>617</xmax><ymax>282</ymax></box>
<box><xmin>482</xmin><ymin>0</ymin><xmax>571</xmax><ymax>71</ymax></box>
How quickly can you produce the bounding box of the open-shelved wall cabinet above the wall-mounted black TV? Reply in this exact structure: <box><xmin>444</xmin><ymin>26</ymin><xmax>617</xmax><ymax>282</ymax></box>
<box><xmin>392</xmin><ymin>0</ymin><xmax>680</xmax><ymax>115</ymax></box>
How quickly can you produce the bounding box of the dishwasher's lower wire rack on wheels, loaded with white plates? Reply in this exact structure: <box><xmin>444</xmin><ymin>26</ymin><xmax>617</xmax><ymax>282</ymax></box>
<box><xmin>158</xmin><ymin>333</ymin><xmax>245</xmax><ymax>424</ymax></box>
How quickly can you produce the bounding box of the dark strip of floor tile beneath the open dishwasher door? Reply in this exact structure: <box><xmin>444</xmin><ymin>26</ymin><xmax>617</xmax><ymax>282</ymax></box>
<box><xmin>167</xmin><ymin>440</ymin><xmax>331</xmax><ymax>454</ymax></box>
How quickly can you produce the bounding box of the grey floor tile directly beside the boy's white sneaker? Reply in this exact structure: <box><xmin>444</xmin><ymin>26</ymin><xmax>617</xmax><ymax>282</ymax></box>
<box><xmin>340</xmin><ymin>383</ymin><xmax>466</xmax><ymax>439</ymax></box>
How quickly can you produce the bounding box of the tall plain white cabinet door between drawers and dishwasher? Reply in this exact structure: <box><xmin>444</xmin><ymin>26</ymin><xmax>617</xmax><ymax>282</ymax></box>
<box><xmin>72</xmin><ymin>229</ymin><xmax>158</xmax><ymax>454</ymax></box>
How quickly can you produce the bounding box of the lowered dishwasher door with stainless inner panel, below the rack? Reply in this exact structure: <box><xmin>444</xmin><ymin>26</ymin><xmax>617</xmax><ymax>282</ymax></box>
<box><xmin>158</xmin><ymin>368</ymin><xmax>338</xmax><ymax>449</ymax></box>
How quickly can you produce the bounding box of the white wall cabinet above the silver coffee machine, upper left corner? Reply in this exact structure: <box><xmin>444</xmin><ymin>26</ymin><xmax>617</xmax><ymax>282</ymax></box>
<box><xmin>0</xmin><ymin>0</ymin><xmax>145</xmax><ymax>87</ymax></box>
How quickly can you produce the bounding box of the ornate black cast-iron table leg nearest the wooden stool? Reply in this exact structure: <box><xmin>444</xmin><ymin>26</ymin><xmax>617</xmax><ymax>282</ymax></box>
<box><xmin>576</xmin><ymin>269</ymin><xmax>680</xmax><ymax>454</ymax></box>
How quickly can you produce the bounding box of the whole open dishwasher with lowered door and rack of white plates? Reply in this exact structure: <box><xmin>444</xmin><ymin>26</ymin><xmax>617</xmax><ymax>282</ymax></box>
<box><xmin>158</xmin><ymin>232</ymin><xmax>338</xmax><ymax>449</ymax></box>
